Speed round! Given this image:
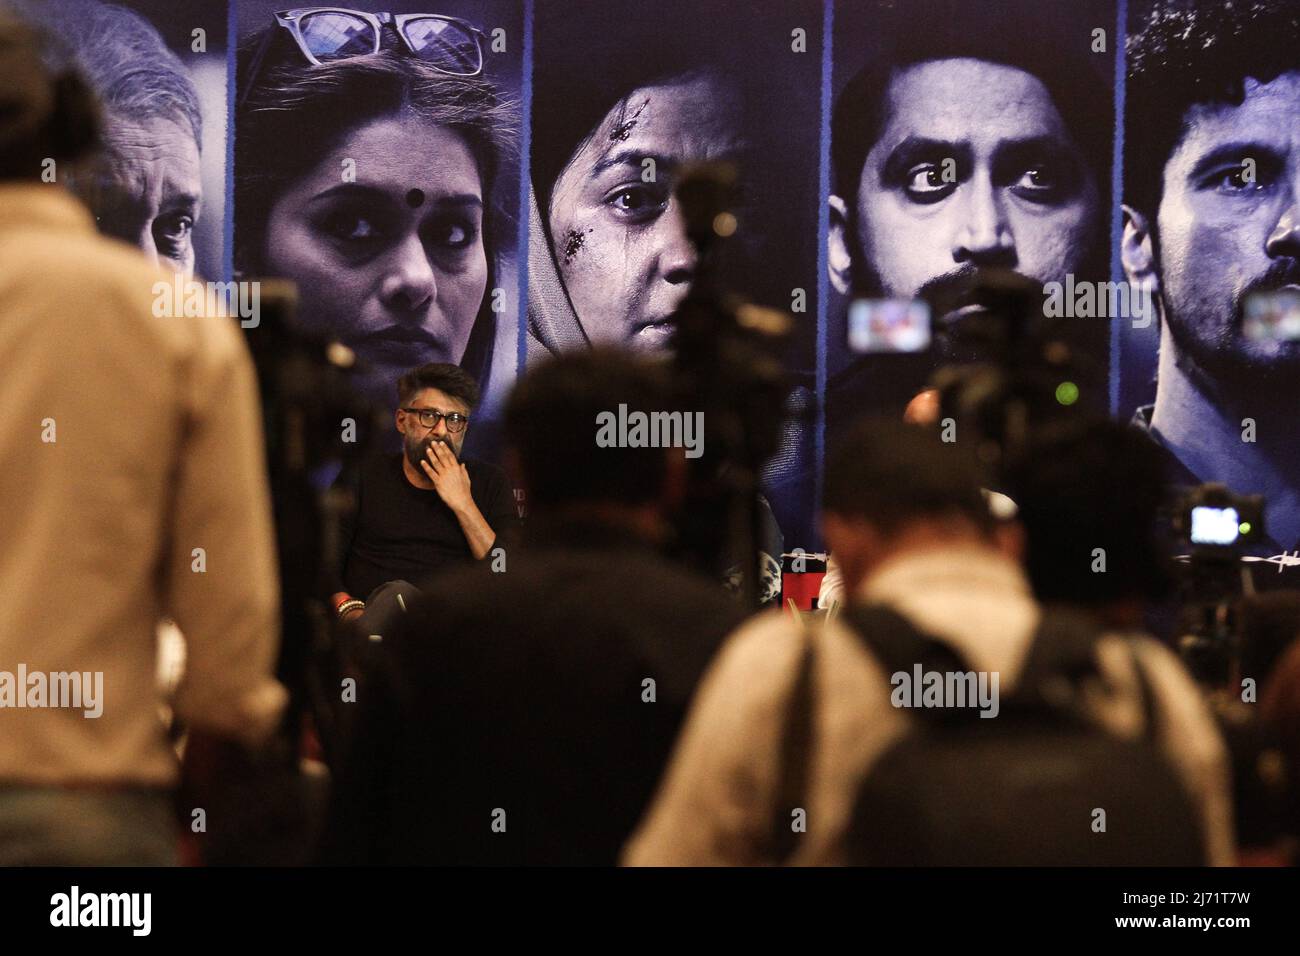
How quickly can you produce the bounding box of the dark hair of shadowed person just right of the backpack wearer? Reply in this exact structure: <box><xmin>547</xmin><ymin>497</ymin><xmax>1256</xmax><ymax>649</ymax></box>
<box><xmin>1009</xmin><ymin>419</ymin><xmax>1170</xmax><ymax>606</ymax></box>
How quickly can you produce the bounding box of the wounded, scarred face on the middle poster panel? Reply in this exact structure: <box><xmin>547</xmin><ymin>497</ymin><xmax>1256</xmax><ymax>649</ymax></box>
<box><xmin>550</xmin><ymin>74</ymin><xmax>741</xmax><ymax>350</ymax></box>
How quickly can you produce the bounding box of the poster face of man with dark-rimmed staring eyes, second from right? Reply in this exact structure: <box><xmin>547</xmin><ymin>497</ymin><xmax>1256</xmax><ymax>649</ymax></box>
<box><xmin>831</xmin><ymin>59</ymin><xmax>1101</xmax><ymax>298</ymax></box>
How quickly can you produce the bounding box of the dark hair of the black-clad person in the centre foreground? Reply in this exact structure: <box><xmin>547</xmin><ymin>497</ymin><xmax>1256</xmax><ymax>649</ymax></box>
<box><xmin>506</xmin><ymin>347</ymin><xmax>672</xmax><ymax>511</ymax></box>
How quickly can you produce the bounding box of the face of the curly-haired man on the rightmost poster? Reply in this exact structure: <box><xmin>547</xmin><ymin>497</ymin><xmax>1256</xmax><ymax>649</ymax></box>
<box><xmin>1156</xmin><ymin>70</ymin><xmax>1300</xmax><ymax>378</ymax></box>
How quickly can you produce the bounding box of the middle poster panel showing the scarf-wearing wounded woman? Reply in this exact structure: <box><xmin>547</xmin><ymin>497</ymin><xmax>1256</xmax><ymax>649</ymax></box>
<box><xmin>528</xmin><ymin>0</ymin><xmax>823</xmax><ymax>548</ymax></box>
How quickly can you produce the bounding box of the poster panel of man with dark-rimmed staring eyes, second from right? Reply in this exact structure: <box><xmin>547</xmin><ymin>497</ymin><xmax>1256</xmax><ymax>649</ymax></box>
<box><xmin>826</xmin><ymin>0</ymin><xmax>1117</xmax><ymax>455</ymax></box>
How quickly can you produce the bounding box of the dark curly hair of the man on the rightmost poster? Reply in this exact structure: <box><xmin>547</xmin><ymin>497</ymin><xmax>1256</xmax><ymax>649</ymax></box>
<box><xmin>1125</xmin><ymin>0</ymin><xmax>1300</xmax><ymax>218</ymax></box>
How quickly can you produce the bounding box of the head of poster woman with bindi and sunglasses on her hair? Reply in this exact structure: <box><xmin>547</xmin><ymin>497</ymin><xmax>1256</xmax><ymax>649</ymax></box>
<box><xmin>234</xmin><ymin>8</ymin><xmax>516</xmax><ymax>426</ymax></box>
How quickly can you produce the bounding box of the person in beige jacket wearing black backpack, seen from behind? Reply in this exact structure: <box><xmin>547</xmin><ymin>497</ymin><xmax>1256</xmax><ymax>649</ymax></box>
<box><xmin>623</xmin><ymin>421</ymin><xmax>1234</xmax><ymax>865</ymax></box>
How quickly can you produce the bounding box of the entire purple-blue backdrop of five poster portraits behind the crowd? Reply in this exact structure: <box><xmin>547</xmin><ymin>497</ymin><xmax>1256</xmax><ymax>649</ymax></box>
<box><xmin>12</xmin><ymin>0</ymin><xmax>1300</xmax><ymax>570</ymax></box>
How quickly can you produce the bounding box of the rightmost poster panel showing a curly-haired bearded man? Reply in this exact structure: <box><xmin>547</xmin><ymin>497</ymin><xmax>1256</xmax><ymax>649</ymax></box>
<box><xmin>1119</xmin><ymin>0</ymin><xmax>1300</xmax><ymax>567</ymax></box>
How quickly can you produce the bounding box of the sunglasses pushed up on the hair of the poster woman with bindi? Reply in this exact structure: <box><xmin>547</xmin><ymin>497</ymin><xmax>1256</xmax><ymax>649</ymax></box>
<box><xmin>239</xmin><ymin>7</ymin><xmax>484</xmax><ymax>104</ymax></box>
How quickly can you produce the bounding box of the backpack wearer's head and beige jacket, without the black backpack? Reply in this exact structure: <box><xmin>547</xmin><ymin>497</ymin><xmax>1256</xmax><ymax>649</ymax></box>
<box><xmin>623</xmin><ymin>423</ymin><xmax>1234</xmax><ymax>866</ymax></box>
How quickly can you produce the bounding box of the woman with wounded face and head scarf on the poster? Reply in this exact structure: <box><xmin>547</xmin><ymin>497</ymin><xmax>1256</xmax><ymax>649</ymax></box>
<box><xmin>529</xmin><ymin>3</ymin><xmax>788</xmax><ymax>355</ymax></box>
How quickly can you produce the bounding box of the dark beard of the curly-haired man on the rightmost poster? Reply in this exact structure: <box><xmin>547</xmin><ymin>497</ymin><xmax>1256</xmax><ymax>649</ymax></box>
<box><xmin>1161</xmin><ymin>258</ymin><xmax>1300</xmax><ymax>394</ymax></box>
